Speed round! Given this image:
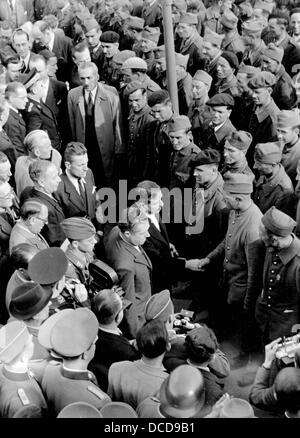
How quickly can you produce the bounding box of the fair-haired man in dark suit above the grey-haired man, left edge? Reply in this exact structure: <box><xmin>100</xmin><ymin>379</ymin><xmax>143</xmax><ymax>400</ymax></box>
<box><xmin>4</xmin><ymin>82</ymin><xmax>28</xmax><ymax>157</ymax></box>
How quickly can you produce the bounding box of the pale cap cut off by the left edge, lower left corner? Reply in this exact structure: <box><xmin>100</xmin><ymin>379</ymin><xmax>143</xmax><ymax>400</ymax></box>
<box><xmin>0</xmin><ymin>321</ymin><xmax>29</xmax><ymax>363</ymax></box>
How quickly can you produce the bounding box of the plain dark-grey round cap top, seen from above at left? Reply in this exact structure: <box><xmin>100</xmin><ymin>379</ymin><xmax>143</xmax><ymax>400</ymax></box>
<box><xmin>28</xmin><ymin>247</ymin><xmax>68</xmax><ymax>285</ymax></box>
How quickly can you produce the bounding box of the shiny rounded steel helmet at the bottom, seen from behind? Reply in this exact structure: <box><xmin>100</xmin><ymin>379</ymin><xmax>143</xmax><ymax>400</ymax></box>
<box><xmin>159</xmin><ymin>365</ymin><xmax>205</xmax><ymax>418</ymax></box>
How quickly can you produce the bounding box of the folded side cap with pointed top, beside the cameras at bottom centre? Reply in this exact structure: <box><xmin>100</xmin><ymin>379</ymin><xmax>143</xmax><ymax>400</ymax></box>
<box><xmin>145</xmin><ymin>289</ymin><xmax>174</xmax><ymax>323</ymax></box>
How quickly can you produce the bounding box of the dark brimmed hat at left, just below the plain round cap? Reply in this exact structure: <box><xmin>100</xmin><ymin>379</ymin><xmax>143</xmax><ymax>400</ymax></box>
<box><xmin>9</xmin><ymin>281</ymin><xmax>52</xmax><ymax>321</ymax></box>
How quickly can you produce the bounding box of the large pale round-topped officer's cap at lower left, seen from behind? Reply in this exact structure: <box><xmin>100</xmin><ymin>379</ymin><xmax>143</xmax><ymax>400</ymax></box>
<box><xmin>50</xmin><ymin>308</ymin><xmax>98</xmax><ymax>357</ymax></box>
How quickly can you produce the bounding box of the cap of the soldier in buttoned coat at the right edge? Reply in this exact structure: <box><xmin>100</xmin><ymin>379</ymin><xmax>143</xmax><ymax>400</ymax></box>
<box><xmin>261</xmin><ymin>206</ymin><xmax>297</xmax><ymax>237</ymax></box>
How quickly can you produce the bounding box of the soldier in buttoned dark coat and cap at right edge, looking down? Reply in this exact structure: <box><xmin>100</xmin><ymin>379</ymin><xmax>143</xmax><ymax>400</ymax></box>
<box><xmin>244</xmin><ymin>207</ymin><xmax>300</xmax><ymax>344</ymax></box>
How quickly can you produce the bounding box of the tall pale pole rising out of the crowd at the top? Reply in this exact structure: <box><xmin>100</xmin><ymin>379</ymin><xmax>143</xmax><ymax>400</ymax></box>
<box><xmin>161</xmin><ymin>0</ymin><xmax>179</xmax><ymax>115</ymax></box>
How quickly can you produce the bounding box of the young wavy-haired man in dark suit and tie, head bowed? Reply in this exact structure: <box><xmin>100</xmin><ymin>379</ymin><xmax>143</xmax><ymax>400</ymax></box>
<box><xmin>54</xmin><ymin>142</ymin><xmax>96</xmax><ymax>221</ymax></box>
